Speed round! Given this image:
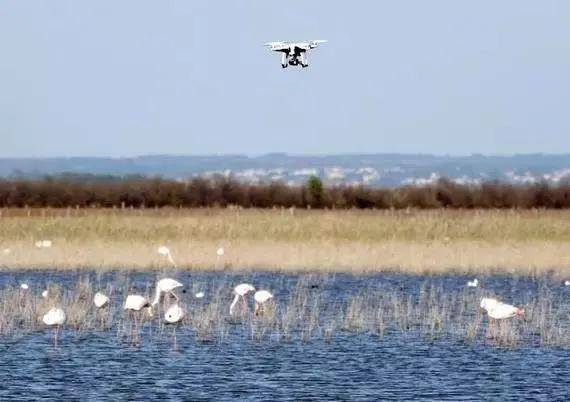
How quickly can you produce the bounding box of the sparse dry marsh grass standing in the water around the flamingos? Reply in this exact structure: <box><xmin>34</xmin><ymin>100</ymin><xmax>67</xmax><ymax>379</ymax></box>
<box><xmin>0</xmin><ymin>275</ymin><xmax>570</xmax><ymax>348</ymax></box>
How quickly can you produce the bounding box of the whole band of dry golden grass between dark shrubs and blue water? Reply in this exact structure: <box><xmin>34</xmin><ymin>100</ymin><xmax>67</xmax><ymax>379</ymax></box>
<box><xmin>0</xmin><ymin>209</ymin><xmax>570</xmax><ymax>277</ymax></box>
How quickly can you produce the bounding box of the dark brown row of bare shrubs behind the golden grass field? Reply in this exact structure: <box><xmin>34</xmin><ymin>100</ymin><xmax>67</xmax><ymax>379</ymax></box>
<box><xmin>0</xmin><ymin>176</ymin><xmax>570</xmax><ymax>209</ymax></box>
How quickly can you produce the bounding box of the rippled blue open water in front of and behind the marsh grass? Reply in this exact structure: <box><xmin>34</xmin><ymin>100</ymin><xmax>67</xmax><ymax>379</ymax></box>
<box><xmin>0</xmin><ymin>271</ymin><xmax>570</xmax><ymax>401</ymax></box>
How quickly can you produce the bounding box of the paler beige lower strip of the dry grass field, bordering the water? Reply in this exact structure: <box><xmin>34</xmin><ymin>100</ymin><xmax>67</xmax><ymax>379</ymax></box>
<box><xmin>0</xmin><ymin>241</ymin><xmax>570</xmax><ymax>277</ymax></box>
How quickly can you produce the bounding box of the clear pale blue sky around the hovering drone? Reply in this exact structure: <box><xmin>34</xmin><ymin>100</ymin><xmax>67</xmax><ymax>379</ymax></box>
<box><xmin>0</xmin><ymin>0</ymin><xmax>570</xmax><ymax>157</ymax></box>
